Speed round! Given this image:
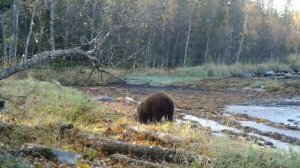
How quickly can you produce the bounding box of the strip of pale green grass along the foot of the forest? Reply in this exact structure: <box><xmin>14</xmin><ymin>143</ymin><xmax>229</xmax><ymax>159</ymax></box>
<box><xmin>2</xmin><ymin>61</ymin><xmax>290</xmax><ymax>86</ymax></box>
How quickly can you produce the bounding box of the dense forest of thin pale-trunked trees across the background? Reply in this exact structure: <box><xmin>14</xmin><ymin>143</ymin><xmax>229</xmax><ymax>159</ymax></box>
<box><xmin>0</xmin><ymin>0</ymin><xmax>300</xmax><ymax>68</ymax></box>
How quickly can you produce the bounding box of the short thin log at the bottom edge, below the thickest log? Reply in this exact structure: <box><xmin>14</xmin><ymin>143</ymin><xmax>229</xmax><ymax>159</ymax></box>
<box><xmin>109</xmin><ymin>154</ymin><xmax>168</xmax><ymax>168</ymax></box>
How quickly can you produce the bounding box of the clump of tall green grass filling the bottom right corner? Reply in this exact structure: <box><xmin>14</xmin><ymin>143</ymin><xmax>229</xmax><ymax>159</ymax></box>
<box><xmin>211</xmin><ymin>139</ymin><xmax>300</xmax><ymax>168</ymax></box>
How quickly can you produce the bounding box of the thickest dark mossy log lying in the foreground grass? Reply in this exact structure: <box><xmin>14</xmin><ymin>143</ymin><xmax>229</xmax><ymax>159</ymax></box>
<box><xmin>89</xmin><ymin>137</ymin><xmax>209</xmax><ymax>163</ymax></box>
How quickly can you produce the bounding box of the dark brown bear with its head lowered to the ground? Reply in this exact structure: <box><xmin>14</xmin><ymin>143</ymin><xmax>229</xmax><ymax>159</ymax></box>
<box><xmin>137</xmin><ymin>92</ymin><xmax>175</xmax><ymax>124</ymax></box>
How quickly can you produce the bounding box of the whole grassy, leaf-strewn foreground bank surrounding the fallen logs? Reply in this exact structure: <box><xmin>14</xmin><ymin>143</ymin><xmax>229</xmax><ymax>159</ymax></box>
<box><xmin>0</xmin><ymin>78</ymin><xmax>300</xmax><ymax>168</ymax></box>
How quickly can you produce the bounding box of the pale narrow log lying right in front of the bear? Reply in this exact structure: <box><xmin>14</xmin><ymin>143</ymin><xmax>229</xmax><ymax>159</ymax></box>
<box><xmin>129</xmin><ymin>126</ymin><xmax>185</xmax><ymax>144</ymax></box>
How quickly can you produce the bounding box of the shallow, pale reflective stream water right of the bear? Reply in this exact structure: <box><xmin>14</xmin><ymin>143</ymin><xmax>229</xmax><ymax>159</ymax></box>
<box><xmin>182</xmin><ymin>98</ymin><xmax>300</xmax><ymax>151</ymax></box>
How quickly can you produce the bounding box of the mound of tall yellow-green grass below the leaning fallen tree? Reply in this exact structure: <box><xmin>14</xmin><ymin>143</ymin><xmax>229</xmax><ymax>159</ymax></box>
<box><xmin>0</xmin><ymin>79</ymin><xmax>102</xmax><ymax>125</ymax></box>
